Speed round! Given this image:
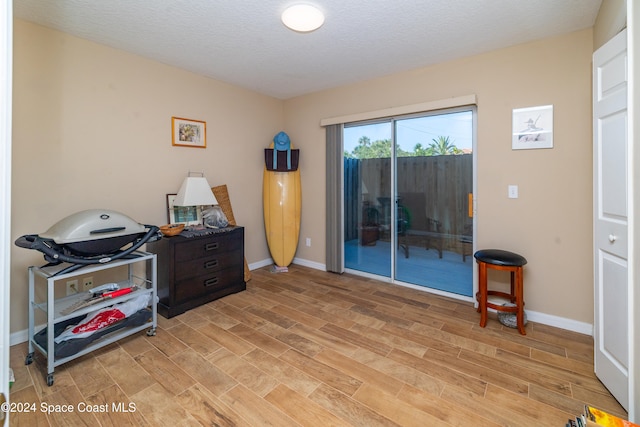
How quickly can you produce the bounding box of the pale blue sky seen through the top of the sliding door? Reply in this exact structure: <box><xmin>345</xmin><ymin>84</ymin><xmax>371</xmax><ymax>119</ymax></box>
<box><xmin>344</xmin><ymin>111</ymin><xmax>473</xmax><ymax>153</ymax></box>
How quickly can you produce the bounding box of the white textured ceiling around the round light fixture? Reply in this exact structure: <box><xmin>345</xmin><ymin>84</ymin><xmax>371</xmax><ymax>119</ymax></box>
<box><xmin>14</xmin><ymin>0</ymin><xmax>602</xmax><ymax>99</ymax></box>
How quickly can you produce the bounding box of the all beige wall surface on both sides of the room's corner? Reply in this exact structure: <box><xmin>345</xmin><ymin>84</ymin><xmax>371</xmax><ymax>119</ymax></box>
<box><xmin>11</xmin><ymin>20</ymin><xmax>593</xmax><ymax>332</ymax></box>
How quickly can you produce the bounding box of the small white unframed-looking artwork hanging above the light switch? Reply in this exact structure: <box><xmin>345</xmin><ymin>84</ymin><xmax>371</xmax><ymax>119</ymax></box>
<box><xmin>511</xmin><ymin>105</ymin><xmax>553</xmax><ymax>150</ymax></box>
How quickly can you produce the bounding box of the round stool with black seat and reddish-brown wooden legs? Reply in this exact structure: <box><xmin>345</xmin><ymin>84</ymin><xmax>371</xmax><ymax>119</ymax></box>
<box><xmin>473</xmin><ymin>249</ymin><xmax>527</xmax><ymax>335</ymax></box>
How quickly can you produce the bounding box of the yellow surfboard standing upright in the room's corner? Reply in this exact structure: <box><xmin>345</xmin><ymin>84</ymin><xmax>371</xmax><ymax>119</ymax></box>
<box><xmin>262</xmin><ymin>143</ymin><xmax>302</xmax><ymax>267</ymax></box>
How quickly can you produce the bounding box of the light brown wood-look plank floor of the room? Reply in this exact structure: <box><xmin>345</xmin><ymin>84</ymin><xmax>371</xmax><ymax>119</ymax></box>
<box><xmin>11</xmin><ymin>265</ymin><xmax>626</xmax><ymax>427</ymax></box>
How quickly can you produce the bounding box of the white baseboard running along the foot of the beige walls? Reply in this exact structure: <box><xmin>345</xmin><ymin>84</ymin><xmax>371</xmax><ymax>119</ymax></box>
<box><xmin>9</xmin><ymin>258</ymin><xmax>593</xmax><ymax>345</ymax></box>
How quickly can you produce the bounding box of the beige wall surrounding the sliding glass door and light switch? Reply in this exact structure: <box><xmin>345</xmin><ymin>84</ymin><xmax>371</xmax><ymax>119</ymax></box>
<box><xmin>284</xmin><ymin>30</ymin><xmax>593</xmax><ymax>323</ymax></box>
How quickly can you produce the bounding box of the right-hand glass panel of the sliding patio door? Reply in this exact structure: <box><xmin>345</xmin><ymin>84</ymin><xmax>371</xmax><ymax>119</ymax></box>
<box><xmin>395</xmin><ymin>110</ymin><xmax>473</xmax><ymax>296</ymax></box>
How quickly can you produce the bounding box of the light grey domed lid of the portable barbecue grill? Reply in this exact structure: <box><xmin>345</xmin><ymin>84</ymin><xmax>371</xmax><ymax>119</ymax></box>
<box><xmin>40</xmin><ymin>209</ymin><xmax>145</xmax><ymax>244</ymax></box>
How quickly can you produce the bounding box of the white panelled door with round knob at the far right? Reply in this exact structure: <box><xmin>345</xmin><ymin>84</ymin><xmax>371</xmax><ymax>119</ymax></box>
<box><xmin>593</xmin><ymin>30</ymin><xmax>630</xmax><ymax>410</ymax></box>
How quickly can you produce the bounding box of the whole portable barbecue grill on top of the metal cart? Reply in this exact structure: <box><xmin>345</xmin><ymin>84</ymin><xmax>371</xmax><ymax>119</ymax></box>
<box><xmin>15</xmin><ymin>209</ymin><xmax>161</xmax><ymax>274</ymax></box>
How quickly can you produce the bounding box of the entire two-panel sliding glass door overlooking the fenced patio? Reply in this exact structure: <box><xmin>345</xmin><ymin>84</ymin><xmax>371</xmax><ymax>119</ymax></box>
<box><xmin>343</xmin><ymin>108</ymin><xmax>474</xmax><ymax>296</ymax></box>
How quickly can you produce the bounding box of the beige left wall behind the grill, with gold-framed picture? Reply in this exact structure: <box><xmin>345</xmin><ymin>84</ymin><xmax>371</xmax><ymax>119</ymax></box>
<box><xmin>11</xmin><ymin>20</ymin><xmax>283</xmax><ymax>332</ymax></box>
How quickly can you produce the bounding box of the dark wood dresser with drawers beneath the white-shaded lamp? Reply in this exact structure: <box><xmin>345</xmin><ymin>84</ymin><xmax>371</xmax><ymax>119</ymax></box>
<box><xmin>147</xmin><ymin>227</ymin><xmax>246</xmax><ymax>318</ymax></box>
